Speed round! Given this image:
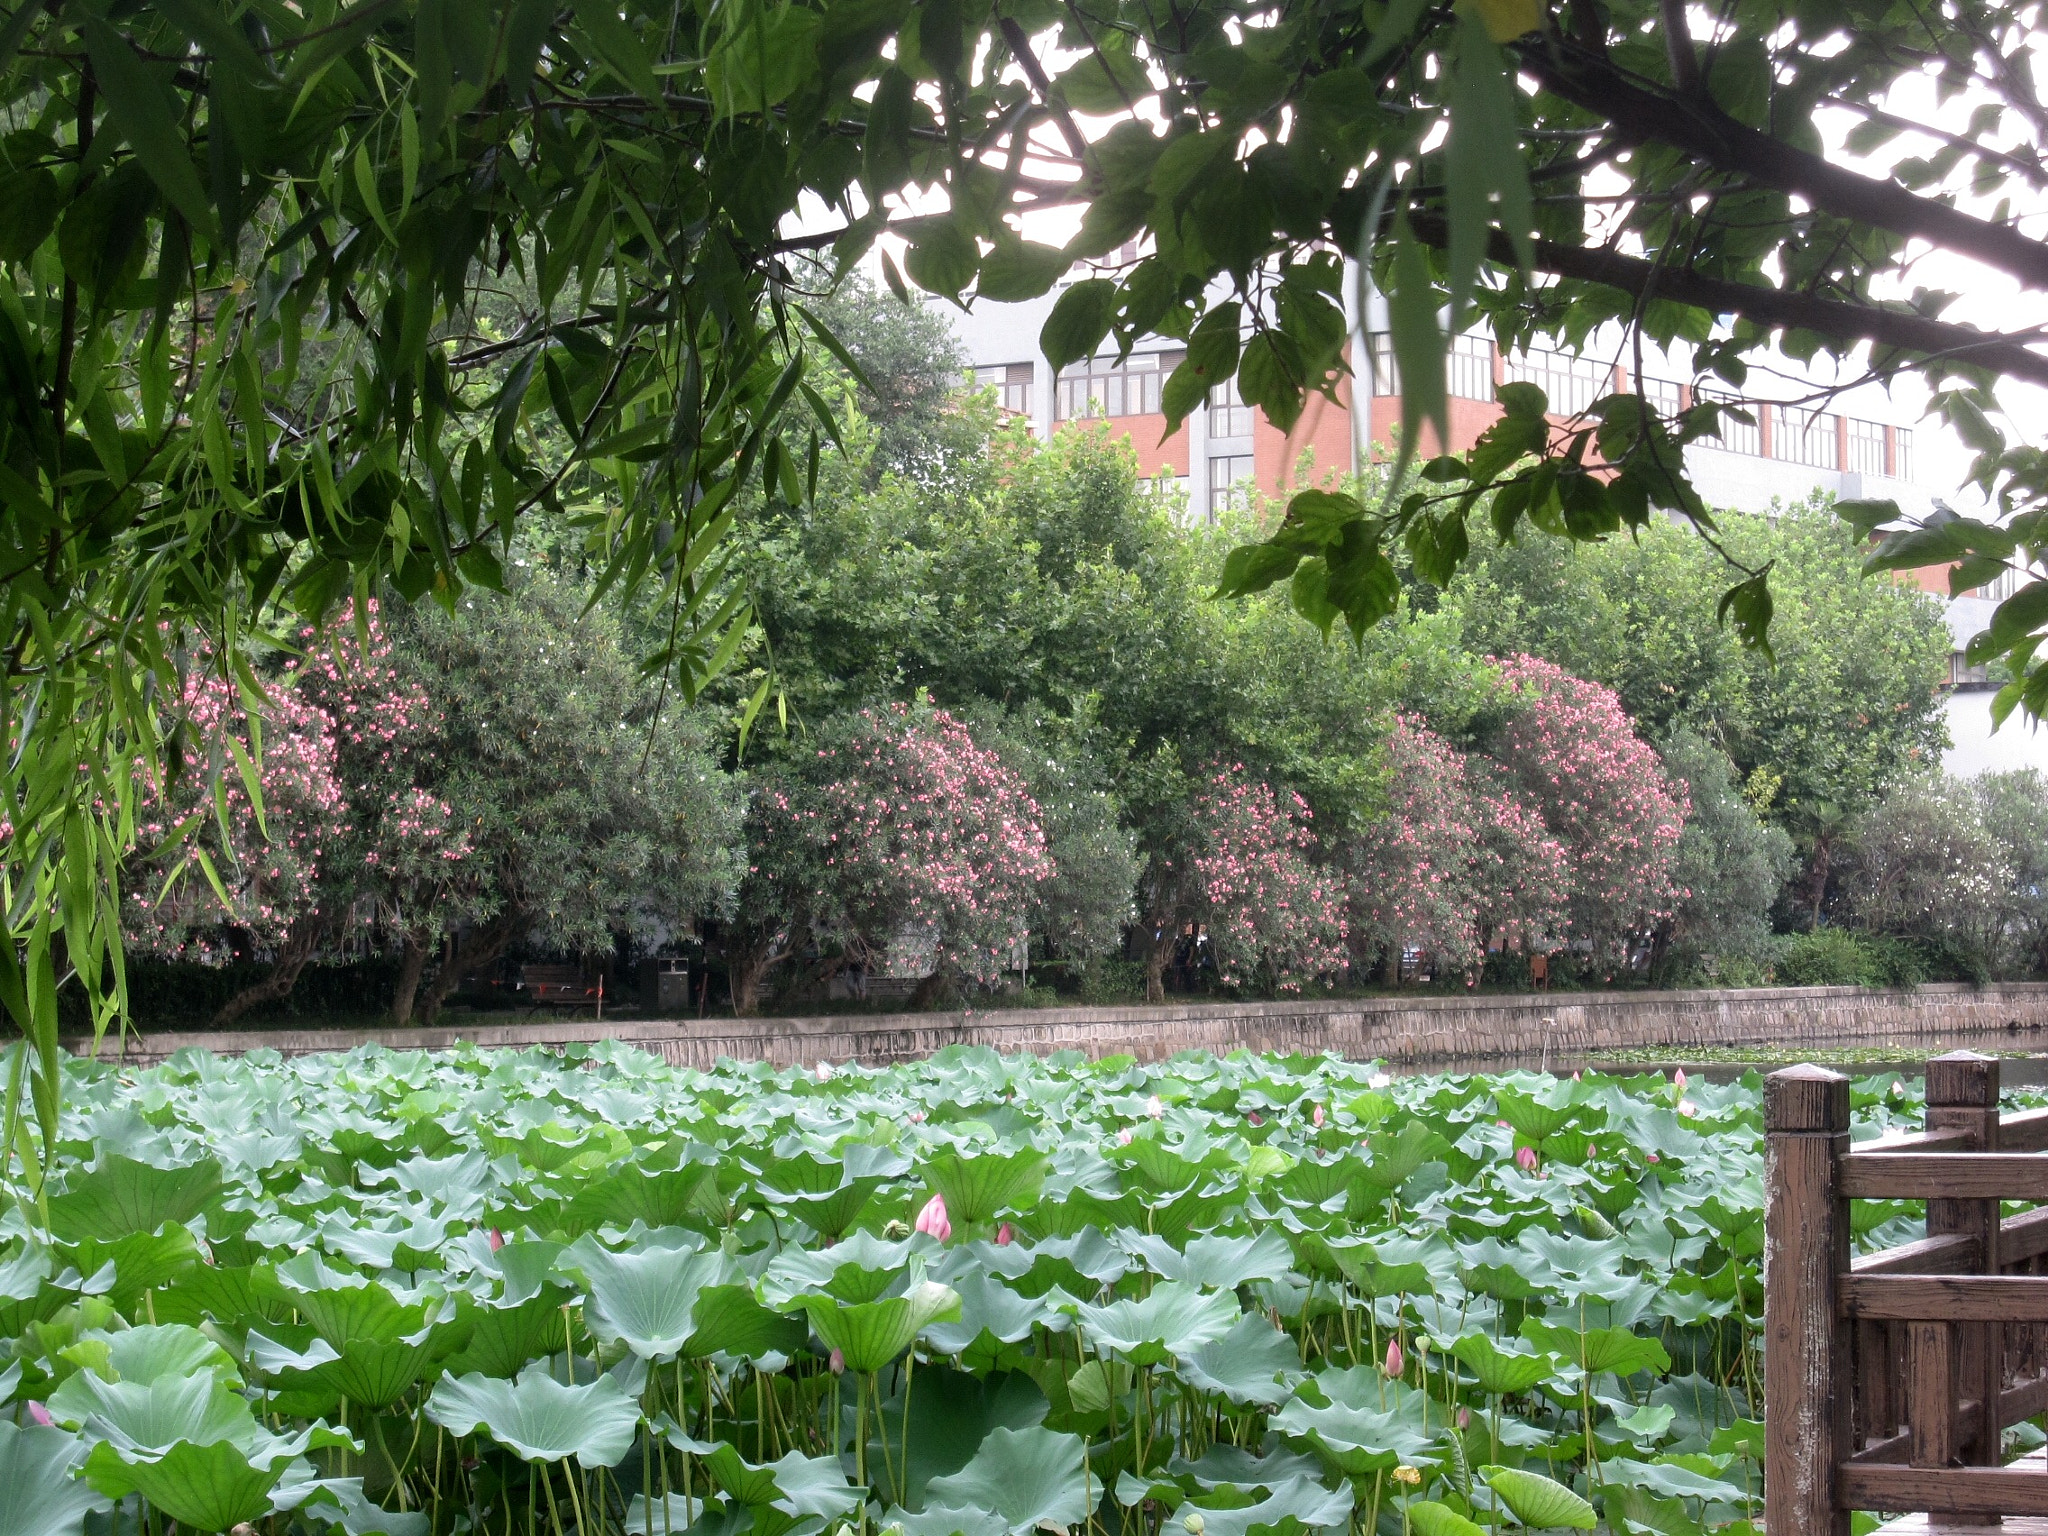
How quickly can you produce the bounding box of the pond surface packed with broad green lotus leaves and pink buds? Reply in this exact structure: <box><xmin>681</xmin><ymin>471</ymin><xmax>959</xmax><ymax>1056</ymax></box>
<box><xmin>0</xmin><ymin>1047</ymin><xmax>1982</xmax><ymax>1536</ymax></box>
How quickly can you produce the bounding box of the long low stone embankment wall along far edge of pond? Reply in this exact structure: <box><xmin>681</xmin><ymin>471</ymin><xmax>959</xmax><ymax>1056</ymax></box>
<box><xmin>72</xmin><ymin>981</ymin><xmax>2048</xmax><ymax>1067</ymax></box>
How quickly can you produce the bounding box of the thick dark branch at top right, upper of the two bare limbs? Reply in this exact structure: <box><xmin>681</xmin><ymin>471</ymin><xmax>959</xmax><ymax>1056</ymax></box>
<box><xmin>1518</xmin><ymin>37</ymin><xmax>2048</xmax><ymax>289</ymax></box>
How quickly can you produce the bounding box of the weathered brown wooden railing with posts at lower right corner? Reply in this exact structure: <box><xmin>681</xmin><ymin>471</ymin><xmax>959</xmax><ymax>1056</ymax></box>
<box><xmin>1763</xmin><ymin>1051</ymin><xmax>2048</xmax><ymax>1536</ymax></box>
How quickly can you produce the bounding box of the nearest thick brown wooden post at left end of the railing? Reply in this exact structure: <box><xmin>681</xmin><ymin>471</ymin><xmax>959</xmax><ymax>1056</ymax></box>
<box><xmin>1763</xmin><ymin>1067</ymin><xmax>1849</xmax><ymax>1536</ymax></box>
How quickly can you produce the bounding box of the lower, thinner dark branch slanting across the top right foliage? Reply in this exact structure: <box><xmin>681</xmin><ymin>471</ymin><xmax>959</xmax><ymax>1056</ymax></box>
<box><xmin>1409</xmin><ymin>211</ymin><xmax>2048</xmax><ymax>385</ymax></box>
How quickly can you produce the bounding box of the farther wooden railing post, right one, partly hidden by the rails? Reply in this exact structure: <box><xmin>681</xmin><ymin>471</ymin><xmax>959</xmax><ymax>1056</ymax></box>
<box><xmin>1915</xmin><ymin>1051</ymin><xmax>2005</xmax><ymax>1526</ymax></box>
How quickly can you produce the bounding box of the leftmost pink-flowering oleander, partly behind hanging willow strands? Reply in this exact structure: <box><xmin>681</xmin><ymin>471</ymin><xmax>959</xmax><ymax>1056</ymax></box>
<box><xmin>125</xmin><ymin>651</ymin><xmax>350</xmax><ymax>1024</ymax></box>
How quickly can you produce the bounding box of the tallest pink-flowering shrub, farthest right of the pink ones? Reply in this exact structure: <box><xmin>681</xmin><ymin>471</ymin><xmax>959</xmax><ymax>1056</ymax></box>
<box><xmin>1491</xmin><ymin>655</ymin><xmax>1690</xmax><ymax>958</ymax></box>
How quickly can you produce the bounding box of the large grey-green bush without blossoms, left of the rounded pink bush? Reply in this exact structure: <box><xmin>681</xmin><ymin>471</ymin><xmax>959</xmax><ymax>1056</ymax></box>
<box><xmin>378</xmin><ymin>571</ymin><xmax>739</xmax><ymax>1022</ymax></box>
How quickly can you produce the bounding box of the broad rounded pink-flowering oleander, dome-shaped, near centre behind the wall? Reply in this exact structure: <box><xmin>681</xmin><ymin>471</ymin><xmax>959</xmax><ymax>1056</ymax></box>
<box><xmin>727</xmin><ymin>702</ymin><xmax>1055</xmax><ymax>1014</ymax></box>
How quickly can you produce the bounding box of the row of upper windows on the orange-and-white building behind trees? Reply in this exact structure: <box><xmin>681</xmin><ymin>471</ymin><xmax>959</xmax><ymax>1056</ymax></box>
<box><xmin>975</xmin><ymin>348</ymin><xmax>1913</xmax><ymax>483</ymax></box>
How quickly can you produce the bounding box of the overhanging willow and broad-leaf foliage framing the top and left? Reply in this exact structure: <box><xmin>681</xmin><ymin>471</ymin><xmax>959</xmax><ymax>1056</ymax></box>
<box><xmin>0</xmin><ymin>0</ymin><xmax>2048</xmax><ymax>1135</ymax></box>
